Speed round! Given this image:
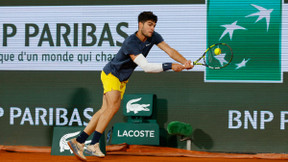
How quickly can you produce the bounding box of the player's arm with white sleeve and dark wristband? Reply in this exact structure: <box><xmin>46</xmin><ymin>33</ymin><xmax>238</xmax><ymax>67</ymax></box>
<box><xmin>130</xmin><ymin>54</ymin><xmax>184</xmax><ymax>73</ymax></box>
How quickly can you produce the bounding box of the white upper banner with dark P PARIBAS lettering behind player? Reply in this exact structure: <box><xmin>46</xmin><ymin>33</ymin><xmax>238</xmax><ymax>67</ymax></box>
<box><xmin>0</xmin><ymin>4</ymin><xmax>206</xmax><ymax>71</ymax></box>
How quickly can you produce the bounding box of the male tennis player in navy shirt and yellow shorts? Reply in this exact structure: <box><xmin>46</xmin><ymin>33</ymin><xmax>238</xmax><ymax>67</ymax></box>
<box><xmin>68</xmin><ymin>12</ymin><xmax>193</xmax><ymax>161</ymax></box>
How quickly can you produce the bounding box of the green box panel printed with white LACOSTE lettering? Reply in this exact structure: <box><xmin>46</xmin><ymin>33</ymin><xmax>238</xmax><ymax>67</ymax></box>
<box><xmin>111</xmin><ymin>123</ymin><xmax>160</xmax><ymax>145</ymax></box>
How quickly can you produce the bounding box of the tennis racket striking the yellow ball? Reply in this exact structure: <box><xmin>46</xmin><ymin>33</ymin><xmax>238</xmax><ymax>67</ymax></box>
<box><xmin>193</xmin><ymin>43</ymin><xmax>233</xmax><ymax>69</ymax></box>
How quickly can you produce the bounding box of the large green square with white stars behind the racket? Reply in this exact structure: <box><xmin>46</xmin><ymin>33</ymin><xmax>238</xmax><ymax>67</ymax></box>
<box><xmin>205</xmin><ymin>0</ymin><xmax>282</xmax><ymax>83</ymax></box>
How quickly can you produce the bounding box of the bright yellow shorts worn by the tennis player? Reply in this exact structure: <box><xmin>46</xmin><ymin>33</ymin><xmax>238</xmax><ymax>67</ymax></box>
<box><xmin>101</xmin><ymin>71</ymin><xmax>128</xmax><ymax>99</ymax></box>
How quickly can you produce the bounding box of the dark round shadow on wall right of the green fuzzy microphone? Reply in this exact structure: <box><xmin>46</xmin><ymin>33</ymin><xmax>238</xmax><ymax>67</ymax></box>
<box><xmin>192</xmin><ymin>129</ymin><xmax>214</xmax><ymax>150</ymax></box>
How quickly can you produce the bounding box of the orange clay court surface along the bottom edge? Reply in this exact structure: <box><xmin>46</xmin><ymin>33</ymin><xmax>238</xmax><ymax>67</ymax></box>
<box><xmin>0</xmin><ymin>144</ymin><xmax>288</xmax><ymax>162</ymax></box>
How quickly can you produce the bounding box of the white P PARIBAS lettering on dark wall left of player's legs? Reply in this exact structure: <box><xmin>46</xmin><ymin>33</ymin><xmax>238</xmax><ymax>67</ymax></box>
<box><xmin>0</xmin><ymin>106</ymin><xmax>95</xmax><ymax>126</ymax></box>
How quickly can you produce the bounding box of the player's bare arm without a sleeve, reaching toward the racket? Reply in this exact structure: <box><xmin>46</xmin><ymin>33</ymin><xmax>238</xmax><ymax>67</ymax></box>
<box><xmin>157</xmin><ymin>41</ymin><xmax>193</xmax><ymax>69</ymax></box>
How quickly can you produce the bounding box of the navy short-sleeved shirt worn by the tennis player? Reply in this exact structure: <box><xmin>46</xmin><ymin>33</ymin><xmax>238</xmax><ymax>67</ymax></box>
<box><xmin>103</xmin><ymin>32</ymin><xmax>163</xmax><ymax>82</ymax></box>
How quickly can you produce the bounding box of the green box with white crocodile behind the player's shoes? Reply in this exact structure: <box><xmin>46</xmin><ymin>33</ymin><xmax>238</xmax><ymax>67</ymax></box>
<box><xmin>51</xmin><ymin>127</ymin><xmax>106</xmax><ymax>156</ymax></box>
